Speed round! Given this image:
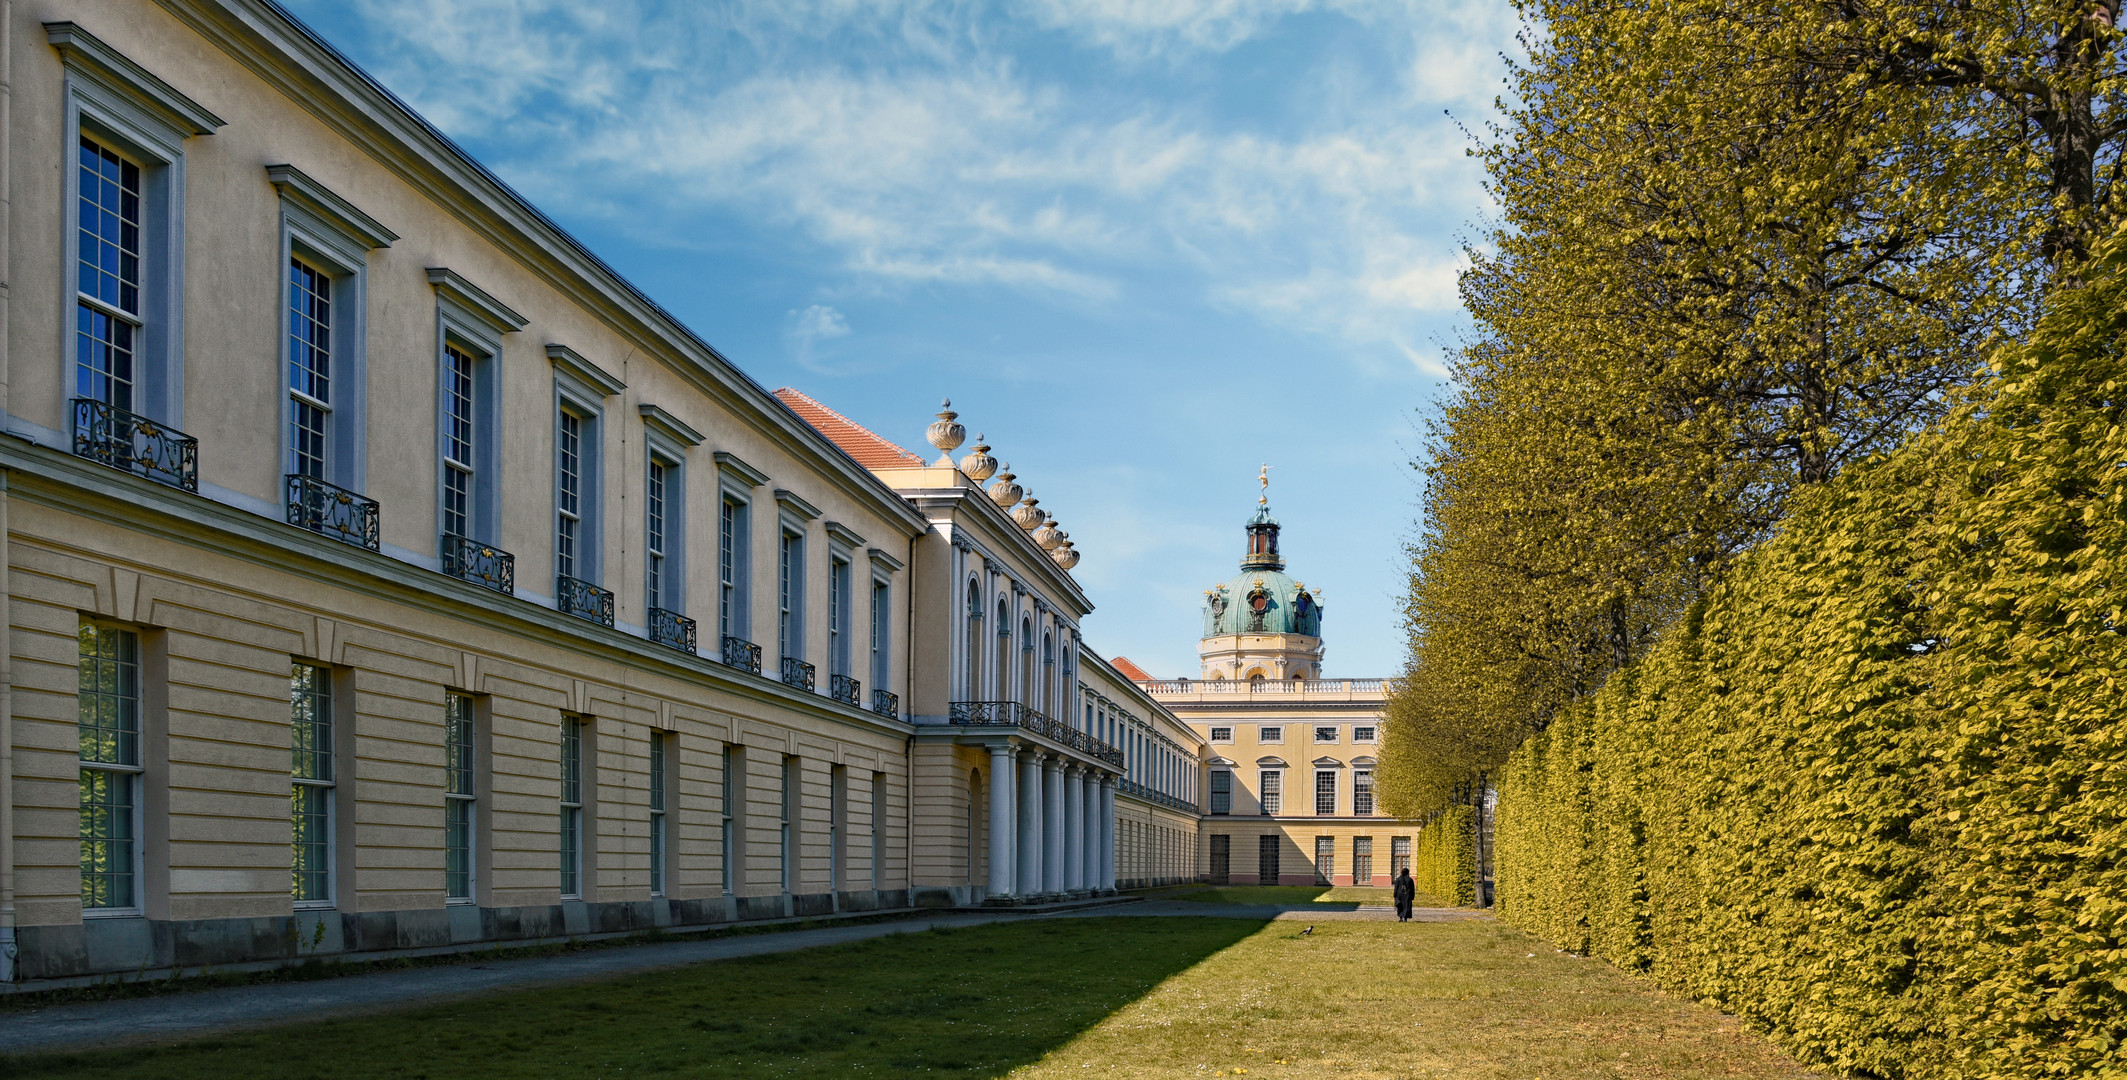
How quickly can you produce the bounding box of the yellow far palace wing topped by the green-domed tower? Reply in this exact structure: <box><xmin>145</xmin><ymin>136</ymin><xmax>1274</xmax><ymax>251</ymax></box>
<box><xmin>1117</xmin><ymin>484</ymin><xmax>1421</xmax><ymax>884</ymax></box>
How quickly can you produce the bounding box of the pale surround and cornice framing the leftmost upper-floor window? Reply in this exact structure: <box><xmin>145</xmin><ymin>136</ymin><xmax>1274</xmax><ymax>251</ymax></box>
<box><xmin>45</xmin><ymin>23</ymin><xmax>223</xmax><ymax>429</ymax></box>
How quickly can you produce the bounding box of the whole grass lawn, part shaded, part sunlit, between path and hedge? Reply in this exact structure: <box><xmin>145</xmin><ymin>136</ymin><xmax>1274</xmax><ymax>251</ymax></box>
<box><xmin>0</xmin><ymin>916</ymin><xmax>1808</xmax><ymax>1080</ymax></box>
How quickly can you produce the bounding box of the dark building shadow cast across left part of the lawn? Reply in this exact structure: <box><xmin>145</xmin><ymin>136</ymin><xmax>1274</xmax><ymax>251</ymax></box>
<box><xmin>0</xmin><ymin>918</ymin><xmax>1263</xmax><ymax>1080</ymax></box>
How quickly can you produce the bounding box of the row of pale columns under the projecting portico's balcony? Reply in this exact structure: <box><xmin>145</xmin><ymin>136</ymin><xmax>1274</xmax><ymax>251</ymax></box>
<box><xmin>989</xmin><ymin>742</ymin><xmax>1115</xmax><ymax>901</ymax></box>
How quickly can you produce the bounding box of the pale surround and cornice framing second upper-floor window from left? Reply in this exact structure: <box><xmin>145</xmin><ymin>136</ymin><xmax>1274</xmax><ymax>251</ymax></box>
<box><xmin>266</xmin><ymin>166</ymin><xmax>398</xmax><ymax>491</ymax></box>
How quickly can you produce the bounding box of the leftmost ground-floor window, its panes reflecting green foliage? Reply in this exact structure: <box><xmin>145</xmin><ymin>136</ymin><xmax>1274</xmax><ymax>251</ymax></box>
<box><xmin>74</xmin><ymin>623</ymin><xmax>140</xmax><ymax>910</ymax></box>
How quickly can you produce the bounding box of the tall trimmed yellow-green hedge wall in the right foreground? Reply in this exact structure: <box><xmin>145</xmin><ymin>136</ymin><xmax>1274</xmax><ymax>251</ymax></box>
<box><xmin>1497</xmin><ymin>240</ymin><xmax>2127</xmax><ymax>1080</ymax></box>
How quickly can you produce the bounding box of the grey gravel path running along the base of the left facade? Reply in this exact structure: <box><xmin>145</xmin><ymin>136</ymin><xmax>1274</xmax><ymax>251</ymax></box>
<box><xmin>0</xmin><ymin>899</ymin><xmax>1487</xmax><ymax>1054</ymax></box>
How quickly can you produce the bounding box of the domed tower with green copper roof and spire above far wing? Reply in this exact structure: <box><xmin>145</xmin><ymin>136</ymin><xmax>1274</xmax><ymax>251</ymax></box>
<box><xmin>1198</xmin><ymin>468</ymin><xmax>1323</xmax><ymax>680</ymax></box>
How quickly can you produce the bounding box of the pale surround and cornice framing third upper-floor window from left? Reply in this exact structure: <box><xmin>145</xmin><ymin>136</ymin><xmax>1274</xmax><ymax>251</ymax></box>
<box><xmin>428</xmin><ymin>266</ymin><xmax>525</xmax><ymax>548</ymax></box>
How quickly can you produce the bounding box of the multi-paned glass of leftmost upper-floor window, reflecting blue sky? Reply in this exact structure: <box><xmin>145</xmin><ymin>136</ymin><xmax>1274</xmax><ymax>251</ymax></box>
<box><xmin>74</xmin><ymin>136</ymin><xmax>143</xmax><ymax>412</ymax></box>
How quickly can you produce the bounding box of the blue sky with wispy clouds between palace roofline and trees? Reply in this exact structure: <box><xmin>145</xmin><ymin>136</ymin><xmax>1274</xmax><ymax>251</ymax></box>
<box><xmin>283</xmin><ymin>0</ymin><xmax>1517</xmax><ymax>676</ymax></box>
